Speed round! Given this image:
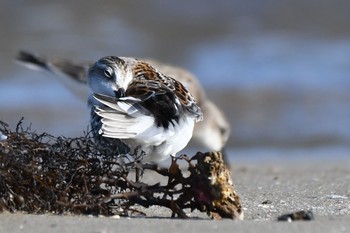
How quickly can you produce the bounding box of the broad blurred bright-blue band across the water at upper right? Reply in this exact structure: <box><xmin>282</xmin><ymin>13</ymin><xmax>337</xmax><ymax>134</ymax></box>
<box><xmin>191</xmin><ymin>34</ymin><xmax>350</xmax><ymax>91</ymax></box>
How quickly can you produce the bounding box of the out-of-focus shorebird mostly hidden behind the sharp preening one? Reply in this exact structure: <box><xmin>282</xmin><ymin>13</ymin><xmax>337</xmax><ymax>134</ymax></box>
<box><xmin>17</xmin><ymin>51</ymin><xmax>230</xmax><ymax>157</ymax></box>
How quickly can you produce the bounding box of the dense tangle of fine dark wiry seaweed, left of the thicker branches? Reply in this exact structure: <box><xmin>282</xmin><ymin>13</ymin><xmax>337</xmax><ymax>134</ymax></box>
<box><xmin>0</xmin><ymin>119</ymin><xmax>132</xmax><ymax>215</ymax></box>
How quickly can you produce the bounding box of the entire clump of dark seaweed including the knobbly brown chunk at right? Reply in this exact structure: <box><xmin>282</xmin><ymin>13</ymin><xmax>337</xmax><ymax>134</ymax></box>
<box><xmin>0</xmin><ymin>120</ymin><xmax>243</xmax><ymax>219</ymax></box>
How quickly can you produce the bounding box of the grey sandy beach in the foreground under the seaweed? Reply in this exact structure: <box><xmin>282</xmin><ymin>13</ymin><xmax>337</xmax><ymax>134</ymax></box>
<box><xmin>0</xmin><ymin>156</ymin><xmax>350</xmax><ymax>233</ymax></box>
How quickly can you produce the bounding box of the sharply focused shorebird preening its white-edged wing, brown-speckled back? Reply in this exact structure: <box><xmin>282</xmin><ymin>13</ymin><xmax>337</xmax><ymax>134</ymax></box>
<box><xmin>88</xmin><ymin>56</ymin><xmax>203</xmax><ymax>162</ymax></box>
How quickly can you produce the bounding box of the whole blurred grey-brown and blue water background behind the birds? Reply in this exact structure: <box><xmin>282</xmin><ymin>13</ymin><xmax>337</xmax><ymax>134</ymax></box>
<box><xmin>0</xmin><ymin>0</ymin><xmax>350</xmax><ymax>157</ymax></box>
